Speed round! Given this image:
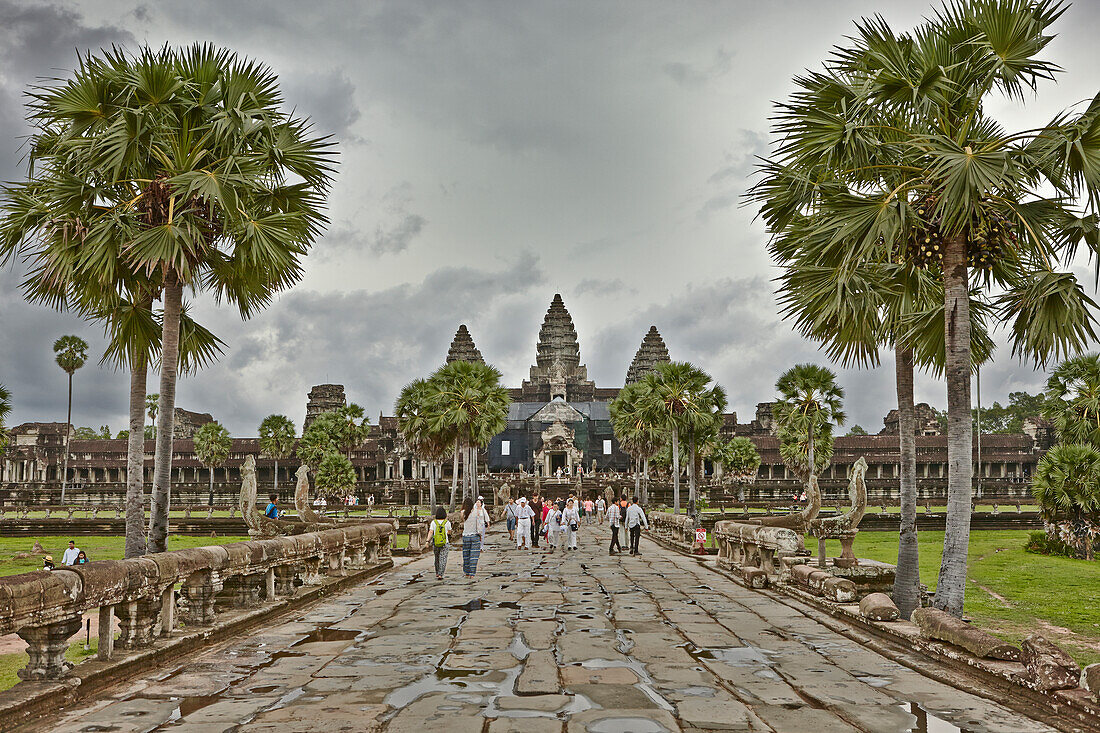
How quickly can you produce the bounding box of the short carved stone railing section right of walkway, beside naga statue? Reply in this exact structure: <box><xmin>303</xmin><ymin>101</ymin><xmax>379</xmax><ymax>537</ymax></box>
<box><xmin>714</xmin><ymin>521</ymin><xmax>806</xmax><ymax>588</ymax></box>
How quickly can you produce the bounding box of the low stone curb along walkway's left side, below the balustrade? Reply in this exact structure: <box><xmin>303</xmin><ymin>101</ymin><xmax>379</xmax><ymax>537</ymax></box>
<box><xmin>0</xmin><ymin>559</ymin><xmax>394</xmax><ymax>733</ymax></box>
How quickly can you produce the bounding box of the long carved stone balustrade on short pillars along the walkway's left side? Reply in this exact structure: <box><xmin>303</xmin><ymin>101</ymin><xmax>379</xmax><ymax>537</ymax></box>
<box><xmin>0</xmin><ymin>522</ymin><xmax>394</xmax><ymax>680</ymax></box>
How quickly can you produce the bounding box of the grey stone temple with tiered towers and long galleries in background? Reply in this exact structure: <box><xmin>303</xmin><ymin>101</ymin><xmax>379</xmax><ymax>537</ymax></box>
<box><xmin>0</xmin><ymin>295</ymin><xmax>1053</xmax><ymax>504</ymax></box>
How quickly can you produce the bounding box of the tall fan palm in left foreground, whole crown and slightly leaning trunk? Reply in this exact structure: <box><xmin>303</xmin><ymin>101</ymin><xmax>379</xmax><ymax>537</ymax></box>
<box><xmin>0</xmin><ymin>44</ymin><xmax>334</xmax><ymax>551</ymax></box>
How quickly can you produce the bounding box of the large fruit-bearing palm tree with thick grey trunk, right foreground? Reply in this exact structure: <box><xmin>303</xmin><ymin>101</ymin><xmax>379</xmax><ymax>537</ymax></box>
<box><xmin>751</xmin><ymin>0</ymin><xmax>1100</xmax><ymax>615</ymax></box>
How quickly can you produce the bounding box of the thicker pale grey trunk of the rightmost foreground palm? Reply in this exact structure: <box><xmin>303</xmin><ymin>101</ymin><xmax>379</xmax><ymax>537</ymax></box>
<box><xmin>933</xmin><ymin>234</ymin><xmax>974</xmax><ymax>616</ymax></box>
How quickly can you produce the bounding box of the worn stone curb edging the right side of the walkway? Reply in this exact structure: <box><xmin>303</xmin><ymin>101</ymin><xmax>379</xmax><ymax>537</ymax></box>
<box><xmin>647</xmin><ymin>535</ymin><xmax>1100</xmax><ymax>733</ymax></box>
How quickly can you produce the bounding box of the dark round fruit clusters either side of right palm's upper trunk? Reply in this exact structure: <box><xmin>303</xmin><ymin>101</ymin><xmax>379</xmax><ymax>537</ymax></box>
<box><xmin>904</xmin><ymin>195</ymin><xmax>1016</xmax><ymax>270</ymax></box>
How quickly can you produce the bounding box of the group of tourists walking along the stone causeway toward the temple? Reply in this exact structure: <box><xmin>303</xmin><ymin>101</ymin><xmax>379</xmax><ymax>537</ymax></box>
<box><xmin>428</xmin><ymin>494</ymin><xmax>649</xmax><ymax>580</ymax></box>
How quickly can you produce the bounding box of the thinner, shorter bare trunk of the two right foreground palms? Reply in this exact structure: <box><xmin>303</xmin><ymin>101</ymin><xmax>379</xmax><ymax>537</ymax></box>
<box><xmin>893</xmin><ymin>347</ymin><xmax>921</xmax><ymax>619</ymax></box>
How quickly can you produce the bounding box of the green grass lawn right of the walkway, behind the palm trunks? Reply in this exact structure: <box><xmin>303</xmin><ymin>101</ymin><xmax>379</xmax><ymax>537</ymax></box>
<box><xmin>806</xmin><ymin>530</ymin><xmax>1100</xmax><ymax>665</ymax></box>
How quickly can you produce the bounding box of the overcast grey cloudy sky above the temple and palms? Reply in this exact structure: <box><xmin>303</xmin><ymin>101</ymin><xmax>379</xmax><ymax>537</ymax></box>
<box><xmin>0</xmin><ymin>0</ymin><xmax>1100</xmax><ymax>436</ymax></box>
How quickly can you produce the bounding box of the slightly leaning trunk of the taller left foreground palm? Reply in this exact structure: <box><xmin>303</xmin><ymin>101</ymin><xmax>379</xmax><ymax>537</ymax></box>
<box><xmin>149</xmin><ymin>277</ymin><xmax>184</xmax><ymax>553</ymax></box>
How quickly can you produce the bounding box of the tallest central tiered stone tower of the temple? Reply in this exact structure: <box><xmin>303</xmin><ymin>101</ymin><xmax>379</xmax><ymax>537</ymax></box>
<box><xmin>519</xmin><ymin>293</ymin><xmax>596</xmax><ymax>402</ymax></box>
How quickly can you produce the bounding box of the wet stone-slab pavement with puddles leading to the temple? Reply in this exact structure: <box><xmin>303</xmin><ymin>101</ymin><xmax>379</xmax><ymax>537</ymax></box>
<box><xmin>37</xmin><ymin>526</ymin><xmax>1051</xmax><ymax>733</ymax></box>
